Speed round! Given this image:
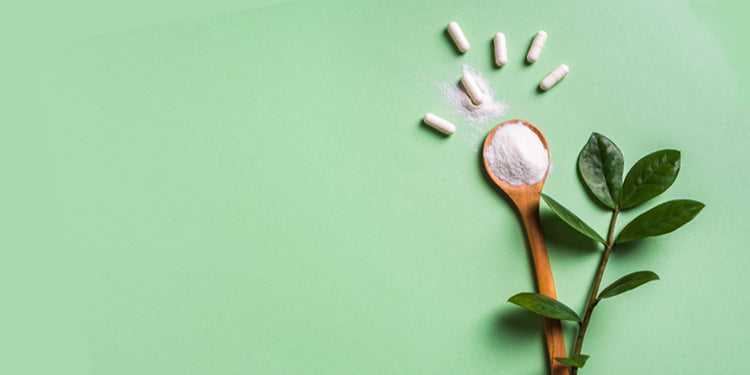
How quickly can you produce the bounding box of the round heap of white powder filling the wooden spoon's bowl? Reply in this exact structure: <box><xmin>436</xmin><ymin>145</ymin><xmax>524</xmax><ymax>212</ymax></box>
<box><xmin>484</xmin><ymin>122</ymin><xmax>549</xmax><ymax>186</ymax></box>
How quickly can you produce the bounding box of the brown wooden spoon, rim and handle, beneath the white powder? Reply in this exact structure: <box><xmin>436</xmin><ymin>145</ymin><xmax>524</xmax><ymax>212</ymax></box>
<box><xmin>483</xmin><ymin>120</ymin><xmax>568</xmax><ymax>375</ymax></box>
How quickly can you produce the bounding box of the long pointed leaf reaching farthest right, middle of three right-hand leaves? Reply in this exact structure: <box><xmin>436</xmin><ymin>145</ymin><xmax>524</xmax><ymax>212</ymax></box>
<box><xmin>615</xmin><ymin>199</ymin><xmax>705</xmax><ymax>243</ymax></box>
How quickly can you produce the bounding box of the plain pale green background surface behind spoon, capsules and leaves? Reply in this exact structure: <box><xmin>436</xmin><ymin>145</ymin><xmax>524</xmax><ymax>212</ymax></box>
<box><xmin>0</xmin><ymin>0</ymin><xmax>750</xmax><ymax>375</ymax></box>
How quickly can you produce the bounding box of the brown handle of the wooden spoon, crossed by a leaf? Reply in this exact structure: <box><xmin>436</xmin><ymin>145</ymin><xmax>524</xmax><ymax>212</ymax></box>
<box><xmin>519</xmin><ymin>200</ymin><xmax>568</xmax><ymax>375</ymax></box>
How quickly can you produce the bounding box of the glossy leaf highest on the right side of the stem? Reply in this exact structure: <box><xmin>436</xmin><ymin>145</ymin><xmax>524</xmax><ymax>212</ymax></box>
<box><xmin>620</xmin><ymin>150</ymin><xmax>680</xmax><ymax>209</ymax></box>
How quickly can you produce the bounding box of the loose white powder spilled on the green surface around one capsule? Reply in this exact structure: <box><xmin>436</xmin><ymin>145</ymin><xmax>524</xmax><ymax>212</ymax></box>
<box><xmin>435</xmin><ymin>64</ymin><xmax>509</xmax><ymax>152</ymax></box>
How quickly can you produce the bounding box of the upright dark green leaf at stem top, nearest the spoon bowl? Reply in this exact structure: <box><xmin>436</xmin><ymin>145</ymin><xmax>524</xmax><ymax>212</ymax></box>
<box><xmin>578</xmin><ymin>133</ymin><xmax>624</xmax><ymax>208</ymax></box>
